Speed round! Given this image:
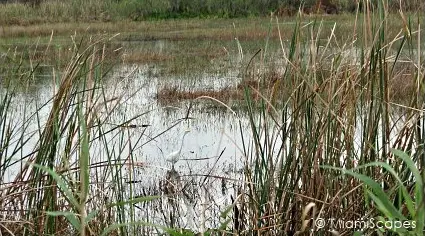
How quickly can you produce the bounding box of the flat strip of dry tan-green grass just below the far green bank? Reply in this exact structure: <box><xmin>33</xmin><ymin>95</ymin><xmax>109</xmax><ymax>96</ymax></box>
<box><xmin>0</xmin><ymin>13</ymin><xmax>415</xmax><ymax>39</ymax></box>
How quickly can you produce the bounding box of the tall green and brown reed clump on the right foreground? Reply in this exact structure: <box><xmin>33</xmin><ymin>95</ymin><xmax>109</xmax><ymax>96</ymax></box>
<box><xmin>233</xmin><ymin>3</ymin><xmax>425</xmax><ymax>235</ymax></box>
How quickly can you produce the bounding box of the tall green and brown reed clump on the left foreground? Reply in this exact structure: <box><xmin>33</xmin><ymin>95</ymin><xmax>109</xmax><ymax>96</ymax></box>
<box><xmin>0</xmin><ymin>37</ymin><xmax>161</xmax><ymax>235</ymax></box>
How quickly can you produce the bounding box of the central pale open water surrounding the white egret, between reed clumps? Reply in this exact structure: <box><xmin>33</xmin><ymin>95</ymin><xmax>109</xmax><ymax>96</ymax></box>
<box><xmin>99</xmin><ymin>67</ymin><xmax>248</xmax><ymax>230</ymax></box>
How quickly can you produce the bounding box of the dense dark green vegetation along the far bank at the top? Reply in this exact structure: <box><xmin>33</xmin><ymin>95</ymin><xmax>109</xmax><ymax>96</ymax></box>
<box><xmin>0</xmin><ymin>0</ymin><xmax>425</xmax><ymax>26</ymax></box>
